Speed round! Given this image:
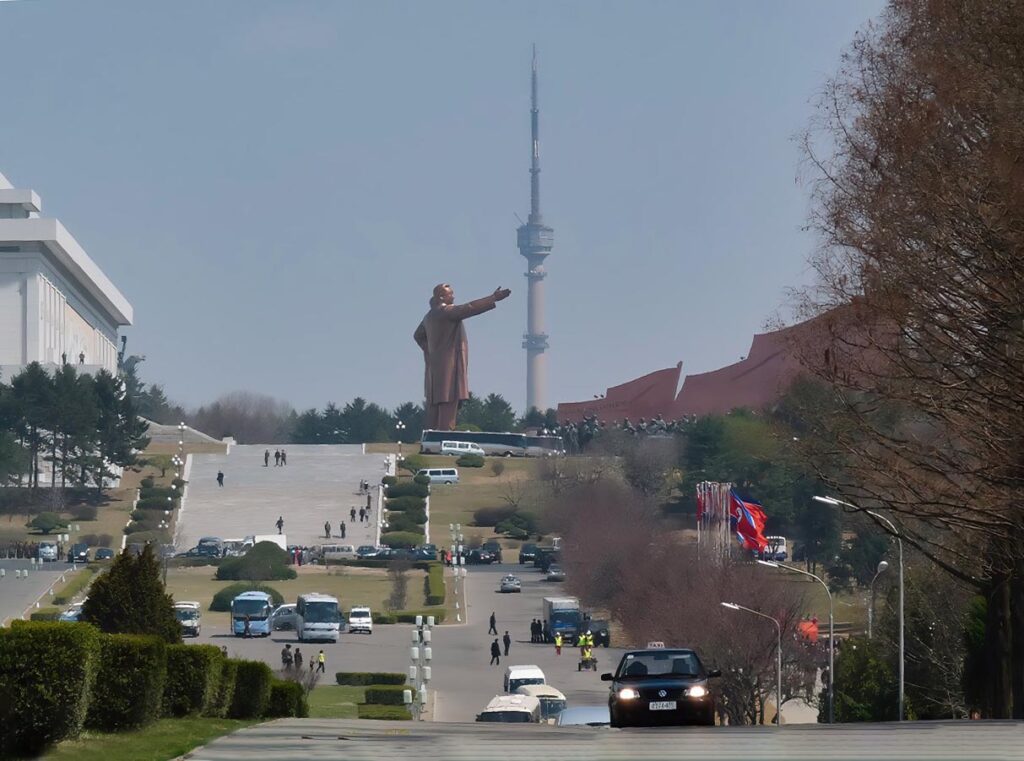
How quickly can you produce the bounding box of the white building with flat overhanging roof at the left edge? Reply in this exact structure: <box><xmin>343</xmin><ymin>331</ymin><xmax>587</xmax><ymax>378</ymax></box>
<box><xmin>0</xmin><ymin>174</ymin><xmax>132</xmax><ymax>381</ymax></box>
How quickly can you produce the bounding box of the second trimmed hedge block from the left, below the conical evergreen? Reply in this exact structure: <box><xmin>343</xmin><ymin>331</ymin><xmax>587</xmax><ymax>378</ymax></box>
<box><xmin>85</xmin><ymin>634</ymin><xmax>167</xmax><ymax>732</ymax></box>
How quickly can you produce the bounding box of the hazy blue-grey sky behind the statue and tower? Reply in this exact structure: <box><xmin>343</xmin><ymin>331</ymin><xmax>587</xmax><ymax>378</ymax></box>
<box><xmin>0</xmin><ymin>0</ymin><xmax>883</xmax><ymax>415</ymax></box>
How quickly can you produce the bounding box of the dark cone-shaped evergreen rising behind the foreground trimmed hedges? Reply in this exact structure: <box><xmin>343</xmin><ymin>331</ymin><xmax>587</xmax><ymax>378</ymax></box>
<box><xmin>82</xmin><ymin>545</ymin><xmax>181</xmax><ymax>643</ymax></box>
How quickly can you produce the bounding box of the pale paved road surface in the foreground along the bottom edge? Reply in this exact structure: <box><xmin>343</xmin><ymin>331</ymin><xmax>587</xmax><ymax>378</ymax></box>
<box><xmin>187</xmin><ymin>719</ymin><xmax>1024</xmax><ymax>761</ymax></box>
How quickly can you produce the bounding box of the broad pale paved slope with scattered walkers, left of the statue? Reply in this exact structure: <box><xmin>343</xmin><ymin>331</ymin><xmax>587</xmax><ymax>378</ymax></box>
<box><xmin>174</xmin><ymin>446</ymin><xmax>384</xmax><ymax>550</ymax></box>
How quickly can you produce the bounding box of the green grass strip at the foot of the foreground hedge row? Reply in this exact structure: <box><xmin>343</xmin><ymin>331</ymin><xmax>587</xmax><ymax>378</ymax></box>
<box><xmin>43</xmin><ymin>718</ymin><xmax>256</xmax><ymax>761</ymax></box>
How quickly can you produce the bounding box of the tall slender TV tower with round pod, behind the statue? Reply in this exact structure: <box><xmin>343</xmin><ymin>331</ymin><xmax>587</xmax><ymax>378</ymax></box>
<box><xmin>516</xmin><ymin>45</ymin><xmax>555</xmax><ymax>412</ymax></box>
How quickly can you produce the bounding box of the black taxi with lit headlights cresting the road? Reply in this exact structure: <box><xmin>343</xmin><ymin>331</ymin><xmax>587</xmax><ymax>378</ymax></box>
<box><xmin>601</xmin><ymin>648</ymin><xmax>722</xmax><ymax>727</ymax></box>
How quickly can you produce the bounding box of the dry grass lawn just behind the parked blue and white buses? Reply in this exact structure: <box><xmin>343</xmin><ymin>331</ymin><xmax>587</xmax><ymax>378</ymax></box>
<box><xmin>167</xmin><ymin>565</ymin><xmax>426</xmax><ymax>616</ymax></box>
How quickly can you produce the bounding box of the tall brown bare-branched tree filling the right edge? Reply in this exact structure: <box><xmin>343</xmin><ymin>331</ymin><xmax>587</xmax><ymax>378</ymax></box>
<box><xmin>803</xmin><ymin>0</ymin><xmax>1024</xmax><ymax>718</ymax></box>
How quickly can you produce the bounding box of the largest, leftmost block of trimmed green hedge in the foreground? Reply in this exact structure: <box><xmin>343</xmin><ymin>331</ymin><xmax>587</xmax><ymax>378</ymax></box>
<box><xmin>0</xmin><ymin>621</ymin><xmax>99</xmax><ymax>756</ymax></box>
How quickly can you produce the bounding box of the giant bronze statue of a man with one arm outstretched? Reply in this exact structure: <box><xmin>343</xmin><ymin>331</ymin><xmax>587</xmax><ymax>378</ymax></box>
<box><xmin>413</xmin><ymin>283</ymin><xmax>511</xmax><ymax>431</ymax></box>
